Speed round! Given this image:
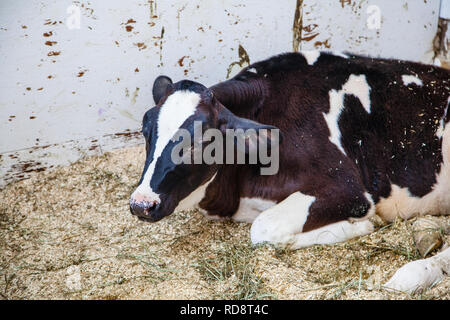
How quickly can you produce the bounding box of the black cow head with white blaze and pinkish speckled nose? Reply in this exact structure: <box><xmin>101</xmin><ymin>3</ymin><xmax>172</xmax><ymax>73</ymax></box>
<box><xmin>130</xmin><ymin>76</ymin><xmax>280</xmax><ymax>222</ymax></box>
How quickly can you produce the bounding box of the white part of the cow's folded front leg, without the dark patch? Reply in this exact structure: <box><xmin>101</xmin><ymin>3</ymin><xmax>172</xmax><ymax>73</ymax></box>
<box><xmin>250</xmin><ymin>192</ymin><xmax>373</xmax><ymax>249</ymax></box>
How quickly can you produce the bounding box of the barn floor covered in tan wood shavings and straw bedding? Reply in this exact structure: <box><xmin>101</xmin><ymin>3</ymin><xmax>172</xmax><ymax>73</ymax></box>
<box><xmin>0</xmin><ymin>147</ymin><xmax>450</xmax><ymax>299</ymax></box>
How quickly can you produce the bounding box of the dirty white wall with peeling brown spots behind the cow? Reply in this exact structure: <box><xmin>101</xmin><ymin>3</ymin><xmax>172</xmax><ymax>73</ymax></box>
<box><xmin>0</xmin><ymin>0</ymin><xmax>440</xmax><ymax>186</ymax></box>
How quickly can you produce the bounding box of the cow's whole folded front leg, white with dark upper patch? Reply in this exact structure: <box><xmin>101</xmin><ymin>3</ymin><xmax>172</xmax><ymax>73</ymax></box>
<box><xmin>251</xmin><ymin>192</ymin><xmax>375</xmax><ymax>249</ymax></box>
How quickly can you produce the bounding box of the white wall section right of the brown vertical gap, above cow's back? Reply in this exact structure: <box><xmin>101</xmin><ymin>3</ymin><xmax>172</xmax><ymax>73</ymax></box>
<box><xmin>302</xmin><ymin>0</ymin><xmax>442</xmax><ymax>63</ymax></box>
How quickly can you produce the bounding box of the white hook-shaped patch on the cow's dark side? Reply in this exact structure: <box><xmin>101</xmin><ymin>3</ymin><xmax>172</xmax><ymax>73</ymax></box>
<box><xmin>324</xmin><ymin>74</ymin><xmax>371</xmax><ymax>154</ymax></box>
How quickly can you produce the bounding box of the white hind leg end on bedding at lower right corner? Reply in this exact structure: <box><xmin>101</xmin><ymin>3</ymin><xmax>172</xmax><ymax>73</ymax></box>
<box><xmin>384</xmin><ymin>248</ymin><xmax>450</xmax><ymax>293</ymax></box>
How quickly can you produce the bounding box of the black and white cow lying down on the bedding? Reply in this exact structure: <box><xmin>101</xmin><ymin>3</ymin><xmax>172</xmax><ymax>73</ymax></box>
<box><xmin>130</xmin><ymin>51</ymin><xmax>450</xmax><ymax>292</ymax></box>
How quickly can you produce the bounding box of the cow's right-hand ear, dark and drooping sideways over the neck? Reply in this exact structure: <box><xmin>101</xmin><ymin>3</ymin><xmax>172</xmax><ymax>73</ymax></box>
<box><xmin>219</xmin><ymin>108</ymin><xmax>282</xmax><ymax>154</ymax></box>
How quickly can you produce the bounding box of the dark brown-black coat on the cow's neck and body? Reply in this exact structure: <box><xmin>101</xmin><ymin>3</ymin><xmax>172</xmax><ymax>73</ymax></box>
<box><xmin>207</xmin><ymin>53</ymin><xmax>449</xmax><ymax>222</ymax></box>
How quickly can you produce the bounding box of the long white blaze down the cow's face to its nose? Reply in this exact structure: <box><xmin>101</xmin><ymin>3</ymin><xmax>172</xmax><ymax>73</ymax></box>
<box><xmin>131</xmin><ymin>91</ymin><xmax>201</xmax><ymax>202</ymax></box>
